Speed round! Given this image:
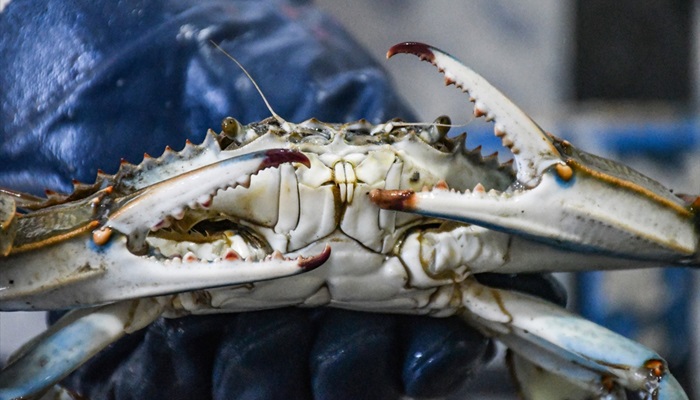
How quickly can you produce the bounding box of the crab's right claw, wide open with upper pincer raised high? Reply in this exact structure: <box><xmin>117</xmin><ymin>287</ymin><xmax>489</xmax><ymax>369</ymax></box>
<box><xmin>378</xmin><ymin>43</ymin><xmax>698</xmax><ymax>264</ymax></box>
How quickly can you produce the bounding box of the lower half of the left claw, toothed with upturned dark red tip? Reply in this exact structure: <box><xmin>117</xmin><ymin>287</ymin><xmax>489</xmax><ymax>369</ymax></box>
<box><xmin>0</xmin><ymin>235</ymin><xmax>331</xmax><ymax>311</ymax></box>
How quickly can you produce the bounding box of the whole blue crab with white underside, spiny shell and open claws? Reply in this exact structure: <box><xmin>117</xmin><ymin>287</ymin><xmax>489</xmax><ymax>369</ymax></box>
<box><xmin>0</xmin><ymin>42</ymin><xmax>698</xmax><ymax>400</ymax></box>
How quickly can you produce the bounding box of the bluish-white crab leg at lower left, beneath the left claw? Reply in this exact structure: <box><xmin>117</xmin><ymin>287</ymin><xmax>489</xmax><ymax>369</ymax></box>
<box><xmin>0</xmin><ymin>298</ymin><xmax>163</xmax><ymax>400</ymax></box>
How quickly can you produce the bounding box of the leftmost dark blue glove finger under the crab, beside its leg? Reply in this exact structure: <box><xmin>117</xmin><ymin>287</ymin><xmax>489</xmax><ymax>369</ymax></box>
<box><xmin>63</xmin><ymin>315</ymin><xmax>228</xmax><ymax>399</ymax></box>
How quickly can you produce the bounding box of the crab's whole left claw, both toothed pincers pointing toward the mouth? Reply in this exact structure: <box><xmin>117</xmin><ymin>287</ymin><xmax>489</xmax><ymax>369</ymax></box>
<box><xmin>0</xmin><ymin>149</ymin><xmax>331</xmax><ymax>310</ymax></box>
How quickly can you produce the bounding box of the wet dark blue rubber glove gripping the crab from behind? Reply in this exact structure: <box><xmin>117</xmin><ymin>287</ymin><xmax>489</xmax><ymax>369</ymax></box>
<box><xmin>0</xmin><ymin>0</ymin><xmax>568</xmax><ymax>399</ymax></box>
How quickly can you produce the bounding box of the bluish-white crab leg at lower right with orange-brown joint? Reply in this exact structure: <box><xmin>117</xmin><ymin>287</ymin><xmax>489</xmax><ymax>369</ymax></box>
<box><xmin>462</xmin><ymin>279</ymin><xmax>687</xmax><ymax>400</ymax></box>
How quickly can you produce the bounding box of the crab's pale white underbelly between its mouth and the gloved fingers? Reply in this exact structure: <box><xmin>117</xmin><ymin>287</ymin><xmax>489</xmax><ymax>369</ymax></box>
<box><xmin>168</xmin><ymin>231</ymin><xmax>459</xmax><ymax>316</ymax></box>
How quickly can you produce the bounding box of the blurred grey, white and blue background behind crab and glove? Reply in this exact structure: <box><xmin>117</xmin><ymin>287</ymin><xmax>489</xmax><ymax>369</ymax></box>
<box><xmin>0</xmin><ymin>0</ymin><xmax>700</xmax><ymax>398</ymax></box>
